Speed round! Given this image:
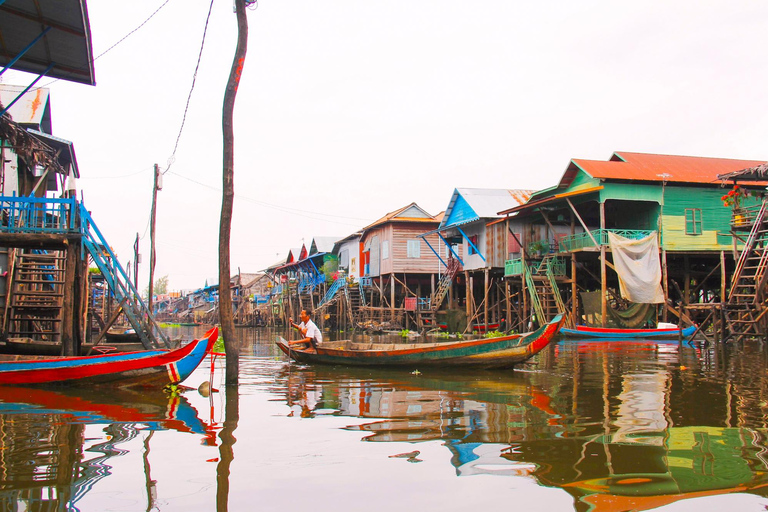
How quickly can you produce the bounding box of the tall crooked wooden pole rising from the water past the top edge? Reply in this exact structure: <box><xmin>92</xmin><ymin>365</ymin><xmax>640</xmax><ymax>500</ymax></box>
<box><xmin>219</xmin><ymin>0</ymin><xmax>248</xmax><ymax>387</ymax></box>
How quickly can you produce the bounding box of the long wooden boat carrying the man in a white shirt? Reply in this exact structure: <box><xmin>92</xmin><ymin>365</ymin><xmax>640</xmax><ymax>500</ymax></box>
<box><xmin>277</xmin><ymin>315</ymin><xmax>564</xmax><ymax>368</ymax></box>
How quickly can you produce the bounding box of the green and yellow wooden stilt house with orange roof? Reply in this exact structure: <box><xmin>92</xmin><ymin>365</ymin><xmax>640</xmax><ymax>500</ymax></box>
<box><xmin>500</xmin><ymin>152</ymin><xmax>762</xmax><ymax>326</ymax></box>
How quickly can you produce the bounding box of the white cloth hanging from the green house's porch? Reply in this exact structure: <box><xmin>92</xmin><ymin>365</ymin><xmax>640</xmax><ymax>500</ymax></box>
<box><xmin>608</xmin><ymin>231</ymin><xmax>664</xmax><ymax>304</ymax></box>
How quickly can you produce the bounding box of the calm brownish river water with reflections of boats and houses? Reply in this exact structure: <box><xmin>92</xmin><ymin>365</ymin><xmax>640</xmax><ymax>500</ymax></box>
<box><xmin>0</xmin><ymin>328</ymin><xmax>768</xmax><ymax>512</ymax></box>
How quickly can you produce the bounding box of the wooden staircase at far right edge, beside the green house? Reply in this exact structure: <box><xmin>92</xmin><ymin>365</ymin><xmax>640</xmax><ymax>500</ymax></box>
<box><xmin>724</xmin><ymin>201</ymin><xmax>768</xmax><ymax>341</ymax></box>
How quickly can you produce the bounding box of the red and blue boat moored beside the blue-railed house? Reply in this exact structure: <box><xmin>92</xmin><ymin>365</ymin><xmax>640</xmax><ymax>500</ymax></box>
<box><xmin>0</xmin><ymin>327</ymin><xmax>219</xmax><ymax>387</ymax></box>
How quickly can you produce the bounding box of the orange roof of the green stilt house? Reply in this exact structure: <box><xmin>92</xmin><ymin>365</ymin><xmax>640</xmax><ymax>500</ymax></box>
<box><xmin>561</xmin><ymin>152</ymin><xmax>765</xmax><ymax>186</ymax></box>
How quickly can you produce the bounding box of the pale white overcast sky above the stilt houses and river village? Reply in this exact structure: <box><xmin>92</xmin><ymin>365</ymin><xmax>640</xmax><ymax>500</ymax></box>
<box><xmin>2</xmin><ymin>0</ymin><xmax>768</xmax><ymax>290</ymax></box>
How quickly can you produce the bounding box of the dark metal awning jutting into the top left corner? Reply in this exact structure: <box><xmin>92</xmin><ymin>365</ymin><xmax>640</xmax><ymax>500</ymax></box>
<box><xmin>0</xmin><ymin>0</ymin><xmax>96</xmax><ymax>85</ymax></box>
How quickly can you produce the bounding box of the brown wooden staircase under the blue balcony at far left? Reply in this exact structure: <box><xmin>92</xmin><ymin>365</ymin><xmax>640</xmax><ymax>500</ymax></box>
<box><xmin>5</xmin><ymin>249</ymin><xmax>66</xmax><ymax>341</ymax></box>
